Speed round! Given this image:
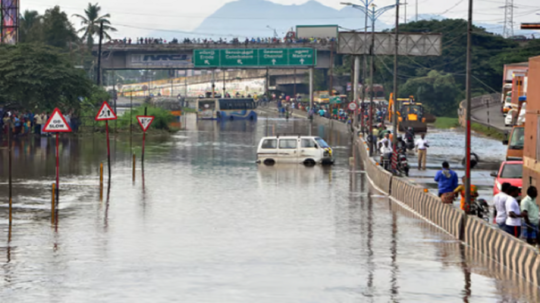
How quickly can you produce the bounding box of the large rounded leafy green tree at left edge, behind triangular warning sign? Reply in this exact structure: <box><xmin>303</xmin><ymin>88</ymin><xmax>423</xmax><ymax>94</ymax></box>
<box><xmin>0</xmin><ymin>44</ymin><xmax>95</xmax><ymax>110</ymax></box>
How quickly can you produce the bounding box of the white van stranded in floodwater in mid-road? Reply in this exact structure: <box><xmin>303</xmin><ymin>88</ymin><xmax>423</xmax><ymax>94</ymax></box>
<box><xmin>257</xmin><ymin>136</ymin><xmax>334</xmax><ymax>165</ymax></box>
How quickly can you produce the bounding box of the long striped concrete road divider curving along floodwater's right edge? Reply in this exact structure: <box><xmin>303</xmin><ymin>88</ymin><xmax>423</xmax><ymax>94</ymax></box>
<box><xmin>259</xmin><ymin>107</ymin><xmax>540</xmax><ymax>286</ymax></box>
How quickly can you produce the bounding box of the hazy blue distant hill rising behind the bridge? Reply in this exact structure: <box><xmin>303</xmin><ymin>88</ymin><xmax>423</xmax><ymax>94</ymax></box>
<box><xmin>193</xmin><ymin>0</ymin><xmax>389</xmax><ymax>38</ymax></box>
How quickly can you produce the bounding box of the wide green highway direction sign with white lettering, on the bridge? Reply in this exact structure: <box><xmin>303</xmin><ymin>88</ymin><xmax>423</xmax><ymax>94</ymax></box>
<box><xmin>193</xmin><ymin>48</ymin><xmax>317</xmax><ymax>68</ymax></box>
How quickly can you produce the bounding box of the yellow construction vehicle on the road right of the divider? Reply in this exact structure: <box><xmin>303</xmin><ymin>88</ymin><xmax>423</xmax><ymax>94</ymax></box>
<box><xmin>388</xmin><ymin>94</ymin><xmax>427</xmax><ymax>133</ymax></box>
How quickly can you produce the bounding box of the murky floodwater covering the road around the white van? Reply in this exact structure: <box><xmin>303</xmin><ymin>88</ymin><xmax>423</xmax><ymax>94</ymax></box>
<box><xmin>0</xmin><ymin>118</ymin><xmax>538</xmax><ymax>303</ymax></box>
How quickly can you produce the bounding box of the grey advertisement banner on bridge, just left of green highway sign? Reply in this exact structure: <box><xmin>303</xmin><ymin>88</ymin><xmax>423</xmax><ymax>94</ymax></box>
<box><xmin>126</xmin><ymin>53</ymin><xmax>193</xmax><ymax>69</ymax></box>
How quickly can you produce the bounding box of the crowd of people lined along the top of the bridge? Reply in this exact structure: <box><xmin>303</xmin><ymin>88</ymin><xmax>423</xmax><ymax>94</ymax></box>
<box><xmin>106</xmin><ymin>37</ymin><xmax>336</xmax><ymax>45</ymax></box>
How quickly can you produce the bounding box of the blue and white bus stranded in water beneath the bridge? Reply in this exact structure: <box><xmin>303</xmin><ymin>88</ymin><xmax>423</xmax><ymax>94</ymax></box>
<box><xmin>195</xmin><ymin>98</ymin><xmax>257</xmax><ymax>120</ymax></box>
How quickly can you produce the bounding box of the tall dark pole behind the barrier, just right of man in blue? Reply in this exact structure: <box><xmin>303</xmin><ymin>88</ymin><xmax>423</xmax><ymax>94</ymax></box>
<box><xmin>465</xmin><ymin>0</ymin><xmax>473</xmax><ymax>214</ymax></box>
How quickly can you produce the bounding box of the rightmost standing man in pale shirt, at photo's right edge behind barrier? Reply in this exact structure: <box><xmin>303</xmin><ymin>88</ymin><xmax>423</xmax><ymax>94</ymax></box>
<box><xmin>520</xmin><ymin>186</ymin><xmax>539</xmax><ymax>245</ymax></box>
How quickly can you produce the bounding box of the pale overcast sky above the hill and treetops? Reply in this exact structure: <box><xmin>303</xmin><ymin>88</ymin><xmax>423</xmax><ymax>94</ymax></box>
<box><xmin>21</xmin><ymin>0</ymin><xmax>540</xmax><ymax>38</ymax></box>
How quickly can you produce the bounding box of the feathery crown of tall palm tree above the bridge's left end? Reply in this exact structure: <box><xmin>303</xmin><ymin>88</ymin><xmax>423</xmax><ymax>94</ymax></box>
<box><xmin>73</xmin><ymin>3</ymin><xmax>116</xmax><ymax>47</ymax></box>
